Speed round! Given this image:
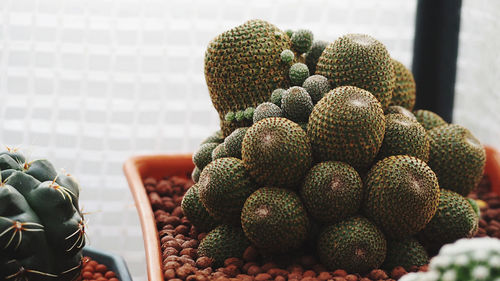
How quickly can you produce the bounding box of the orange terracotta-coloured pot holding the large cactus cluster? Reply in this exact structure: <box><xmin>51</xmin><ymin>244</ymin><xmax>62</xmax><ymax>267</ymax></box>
<box><xmin>123</xmin><ymin>146</ymin><xmax>500</xmax><ymax>281</ymax></box>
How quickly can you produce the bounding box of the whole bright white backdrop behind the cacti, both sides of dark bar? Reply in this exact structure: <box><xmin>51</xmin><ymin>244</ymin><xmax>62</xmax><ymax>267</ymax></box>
<box><xmin>0</xmin><ymin>0</ymin><xmax>500</xmax><ymax>281</ymax></box>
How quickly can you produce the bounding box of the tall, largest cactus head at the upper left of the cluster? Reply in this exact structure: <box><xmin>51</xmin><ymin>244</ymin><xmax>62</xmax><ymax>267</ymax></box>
<box><xmin>205</xmin><ymin>20</ymin><xmax>291</xmax><ymax>137</ymax></box>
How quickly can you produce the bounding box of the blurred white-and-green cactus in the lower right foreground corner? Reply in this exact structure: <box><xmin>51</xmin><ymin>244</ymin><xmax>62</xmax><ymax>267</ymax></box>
<box><xmin>399</xmin><ymin>237</ymin><xmax>500</xmax><ymax>281</ymax></box>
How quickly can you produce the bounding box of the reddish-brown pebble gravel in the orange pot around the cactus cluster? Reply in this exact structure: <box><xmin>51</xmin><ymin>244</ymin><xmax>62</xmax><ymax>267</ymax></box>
<box><xmin>144</xmin><ymin>176</ymin><xmax>500</xmax><ymax>281</ymax></box>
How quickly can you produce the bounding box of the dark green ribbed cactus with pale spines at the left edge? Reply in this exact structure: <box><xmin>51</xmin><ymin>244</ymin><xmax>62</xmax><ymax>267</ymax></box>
<box><xmin>0</xmin><ymin>149</ymin><xmax>85</xmax><ymax>280</ymax></box>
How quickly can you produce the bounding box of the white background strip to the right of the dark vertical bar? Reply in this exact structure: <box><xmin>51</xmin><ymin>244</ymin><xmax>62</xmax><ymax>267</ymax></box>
<box><xmin>453</xmin><ymin>0</ymin><xmax>500</xmax><ymax>149</ymax></box>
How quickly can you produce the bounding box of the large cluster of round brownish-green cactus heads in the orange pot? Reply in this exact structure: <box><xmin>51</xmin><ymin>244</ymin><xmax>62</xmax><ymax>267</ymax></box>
<box><xmin>182</xmin><ymin>20</ymin><xmax>485</xmax><ymax>273</ymax></box>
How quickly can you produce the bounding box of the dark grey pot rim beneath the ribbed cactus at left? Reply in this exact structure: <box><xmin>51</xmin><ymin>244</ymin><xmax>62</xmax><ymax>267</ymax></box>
<box><xmin>83</xmin><ymin>246</ymin><xmax>132</xmax><ymax>281</ymax></box>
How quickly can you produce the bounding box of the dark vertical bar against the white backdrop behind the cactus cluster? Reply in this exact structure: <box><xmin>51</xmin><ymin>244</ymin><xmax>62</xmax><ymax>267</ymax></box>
<box><xmin>413</xmin><ymin>0</ymin><xmax>462</xmax><ymax>122</ymax></box>
